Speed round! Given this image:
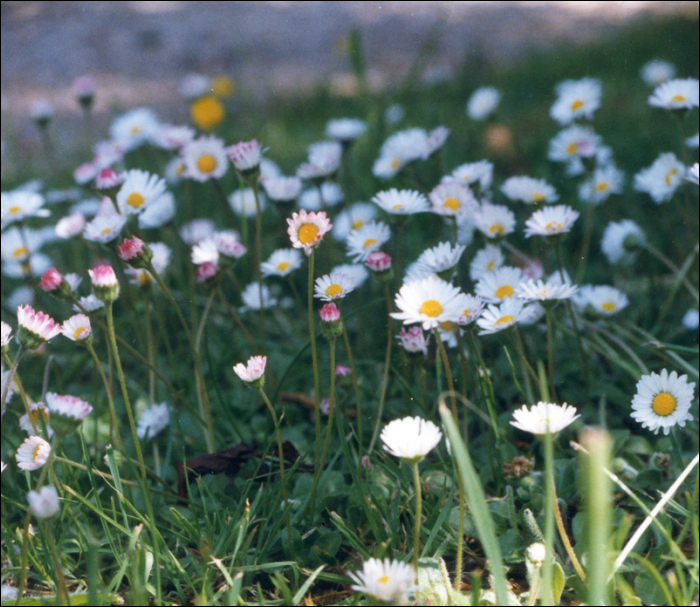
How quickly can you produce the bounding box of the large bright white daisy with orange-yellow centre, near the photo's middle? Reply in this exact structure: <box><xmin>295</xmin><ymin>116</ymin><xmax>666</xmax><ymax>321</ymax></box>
<box><xmin>391</xmin><ymin>278</ymin><xmax>474</xmax><ymax>331</ymax></box>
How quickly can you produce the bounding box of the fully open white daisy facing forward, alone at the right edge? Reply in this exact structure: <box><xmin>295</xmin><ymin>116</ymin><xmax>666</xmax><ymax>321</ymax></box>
<box><xmin>632</xmin><ymin>369</ymin><xmax>695</xmax><ymax>435</ymax></box>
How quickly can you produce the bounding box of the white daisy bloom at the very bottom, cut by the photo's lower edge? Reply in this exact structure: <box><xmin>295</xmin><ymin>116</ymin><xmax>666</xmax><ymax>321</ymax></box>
<box><xmin>348</xmin><ymin>559</ymin><xmax>418</xmax><ymax>605</ymax></box>
